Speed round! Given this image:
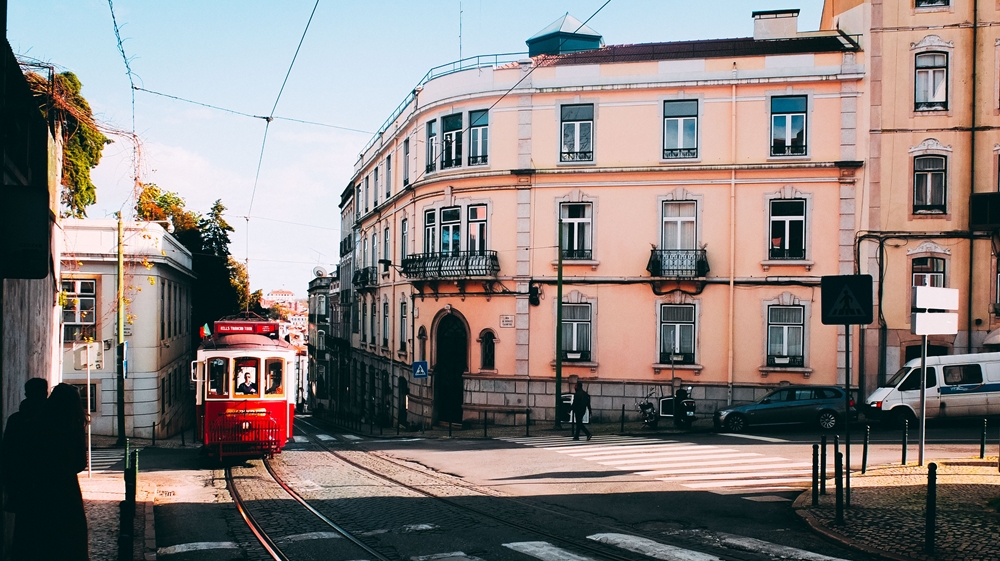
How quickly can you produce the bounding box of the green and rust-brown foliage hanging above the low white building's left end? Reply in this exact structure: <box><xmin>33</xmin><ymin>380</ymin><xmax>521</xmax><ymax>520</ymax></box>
<box><xmin>25</xmin><ymin>71</ymin><xmax>111</xmax><ymax>218</ymax></box>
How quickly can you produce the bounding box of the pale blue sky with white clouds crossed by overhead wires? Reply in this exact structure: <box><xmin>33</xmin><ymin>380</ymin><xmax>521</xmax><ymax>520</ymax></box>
<box><xmin>7</xmin><ymin>0</ymin><xmax>822</xmax><ymax>296</ymax></box>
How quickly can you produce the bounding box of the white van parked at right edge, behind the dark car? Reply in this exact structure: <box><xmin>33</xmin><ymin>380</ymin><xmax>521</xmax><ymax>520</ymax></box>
<box><xmin>865</xmin><ymin>353</ymin><xmax>1000</xmax><ymax>427</ymax></box>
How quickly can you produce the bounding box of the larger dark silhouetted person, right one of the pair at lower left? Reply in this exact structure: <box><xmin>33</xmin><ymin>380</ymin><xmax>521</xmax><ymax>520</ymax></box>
<box><xmin>12</xmin><ymin>384</ymin><xmax>90</xmax><ymax>561</ymax></box>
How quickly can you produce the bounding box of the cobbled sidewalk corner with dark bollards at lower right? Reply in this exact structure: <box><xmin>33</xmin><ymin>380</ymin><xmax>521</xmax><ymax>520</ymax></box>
<box><xmin>793</xmin><ymin>456</ymin><xmax>1000</xmax><ymax>561</ymax></box>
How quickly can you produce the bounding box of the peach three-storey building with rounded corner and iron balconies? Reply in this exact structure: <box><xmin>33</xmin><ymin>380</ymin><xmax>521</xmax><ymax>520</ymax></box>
<box><xmin>337</xmin><ymin>13</ymin><xmax>868</xmax><ymax>424</ymax></box>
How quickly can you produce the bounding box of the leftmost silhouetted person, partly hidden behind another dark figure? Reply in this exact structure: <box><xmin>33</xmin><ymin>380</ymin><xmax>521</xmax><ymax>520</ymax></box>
<box><xmin>2</xmin><ymin>378</ymin><xmax>49</xmax><ymax>556</ymax></box>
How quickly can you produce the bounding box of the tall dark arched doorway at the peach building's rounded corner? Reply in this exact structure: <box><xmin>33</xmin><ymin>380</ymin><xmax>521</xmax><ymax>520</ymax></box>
<box><xmin>434</xmin><ymin>314</ymin><xmax>469</xmax><ymax>423</ymax></box>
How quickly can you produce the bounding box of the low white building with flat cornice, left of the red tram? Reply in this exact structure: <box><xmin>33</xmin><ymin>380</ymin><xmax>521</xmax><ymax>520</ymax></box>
<box><xmin>60</xmin><ymin>219</ymin><xmax>195</xmax><ymax>438</ymax></box>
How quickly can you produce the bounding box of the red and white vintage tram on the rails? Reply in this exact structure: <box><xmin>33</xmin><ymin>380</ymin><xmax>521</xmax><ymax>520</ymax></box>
<box><xmin>191</xmin><ymin>319</ymin><xmax>296</xmax><ymax>458</ymax></box>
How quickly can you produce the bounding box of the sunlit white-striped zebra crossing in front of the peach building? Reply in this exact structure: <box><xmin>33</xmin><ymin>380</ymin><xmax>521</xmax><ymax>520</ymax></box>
<box><xmin>501</xmin><ymin>435</ymin><xmax>812</xmax><ymax>493</ymax></box>
